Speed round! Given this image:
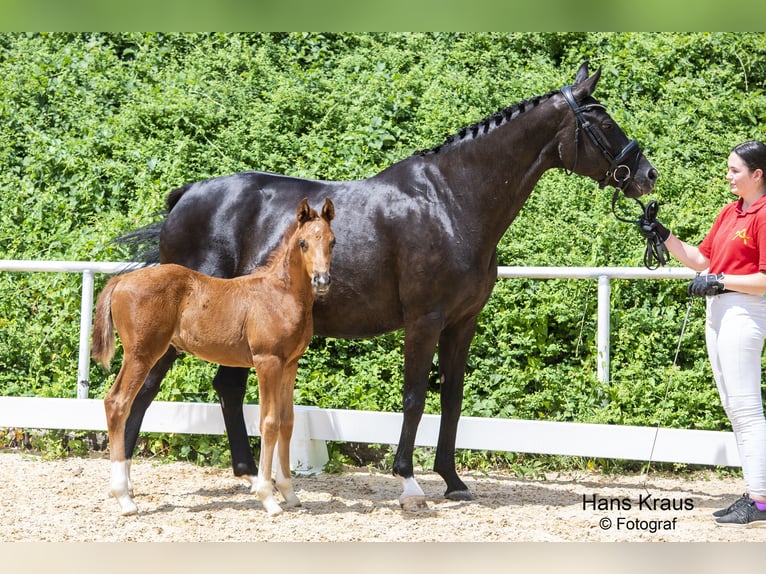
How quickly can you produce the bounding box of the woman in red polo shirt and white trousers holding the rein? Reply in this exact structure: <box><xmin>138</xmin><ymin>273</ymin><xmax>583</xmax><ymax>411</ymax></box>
<box><xmin>639</xmin><ymin>141</ymin><xmax>766</xmax><ymax>527</ymax></box>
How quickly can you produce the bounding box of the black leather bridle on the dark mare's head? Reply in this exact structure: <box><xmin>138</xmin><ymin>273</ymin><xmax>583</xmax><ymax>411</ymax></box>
<box><xmin>561</xmin><ymin>86</ymin><xmax>670</xmax><ymax>269</ymax></box>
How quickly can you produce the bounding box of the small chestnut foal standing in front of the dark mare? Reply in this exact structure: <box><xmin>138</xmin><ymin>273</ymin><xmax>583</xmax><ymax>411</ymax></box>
<box><xmin>93</xmin><ymin>199</ymin><xmax>335</xmax><ymax>515</ymax></box>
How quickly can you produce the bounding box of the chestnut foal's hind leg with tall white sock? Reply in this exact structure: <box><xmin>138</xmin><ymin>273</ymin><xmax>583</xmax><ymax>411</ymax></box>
<box><xmin>104</xmin><ymin>357</ymin><xmax>149</xmax><ymax>516</ymax></box>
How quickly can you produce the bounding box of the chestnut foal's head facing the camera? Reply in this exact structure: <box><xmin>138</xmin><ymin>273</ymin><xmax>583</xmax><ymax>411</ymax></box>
<box><xmin>296</xmin><ymin>198</ymin><xmax>335</xmax><ymax>295</ymax></box>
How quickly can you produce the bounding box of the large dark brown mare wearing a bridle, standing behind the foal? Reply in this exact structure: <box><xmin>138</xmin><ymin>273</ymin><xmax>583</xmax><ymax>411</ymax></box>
<box><xmin>117</xmin><ymin>62</ymin><xmax>657</xmax><ymax>508</ymax></box>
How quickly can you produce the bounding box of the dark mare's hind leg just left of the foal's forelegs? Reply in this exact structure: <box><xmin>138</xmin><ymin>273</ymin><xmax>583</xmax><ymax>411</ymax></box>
<box><xmin>213</xmin><ymin>366</ymin><xmax>258</xmax><ymax>492</ymax></box>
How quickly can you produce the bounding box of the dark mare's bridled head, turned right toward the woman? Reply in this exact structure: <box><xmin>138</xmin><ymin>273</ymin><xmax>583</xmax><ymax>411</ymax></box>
<box><xmin>559</xmin><ymin>61</ymin><xmax>658</xmax><ymax>197</ymax></box>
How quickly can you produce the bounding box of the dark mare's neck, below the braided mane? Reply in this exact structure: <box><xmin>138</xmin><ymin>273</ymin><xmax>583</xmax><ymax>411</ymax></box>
<box><xmin>424</xmin><ymin>99</ymin><xmax>561</xmax><ymax>249</ymax></box>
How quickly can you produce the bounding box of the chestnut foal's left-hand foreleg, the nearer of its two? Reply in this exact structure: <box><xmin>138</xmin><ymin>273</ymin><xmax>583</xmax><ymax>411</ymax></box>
<box><xmin>253</xmin><ymin>357</ymin><xmax>283</xmax><ymax>516</ymax></box>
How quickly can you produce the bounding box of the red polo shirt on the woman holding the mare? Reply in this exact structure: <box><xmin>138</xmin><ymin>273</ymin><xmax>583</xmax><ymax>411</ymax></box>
<box><xmin>699</xmin><ymin>196</ymin><xmax>766</xmax><ymax>275</ymax></box>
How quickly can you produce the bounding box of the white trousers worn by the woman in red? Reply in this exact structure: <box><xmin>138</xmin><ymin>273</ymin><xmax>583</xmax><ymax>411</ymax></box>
<box><xmin>705</xmin><ymin>293</ymin><xmax>766</xmax><ymax>497</ymax></box>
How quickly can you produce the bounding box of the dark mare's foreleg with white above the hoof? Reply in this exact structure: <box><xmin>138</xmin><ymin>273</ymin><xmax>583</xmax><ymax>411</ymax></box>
<box><xmin>393</xmin><ymin>317</ymin><xmax>441</xmax><ymax>510</ymax></box>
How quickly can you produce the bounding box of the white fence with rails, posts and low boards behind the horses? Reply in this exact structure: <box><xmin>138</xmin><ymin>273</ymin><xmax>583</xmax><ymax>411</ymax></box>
<box><xmin>0</xmin><ymin>260</ymin><xmax>739</xmax><ymax>472</ymax></box>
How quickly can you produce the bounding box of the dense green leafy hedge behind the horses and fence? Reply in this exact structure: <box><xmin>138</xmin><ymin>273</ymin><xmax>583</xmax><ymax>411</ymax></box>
<box><xmin>0</xmin><ymin>33</ymin><xmax>766</xmax><ymax>468</ymax></box>
